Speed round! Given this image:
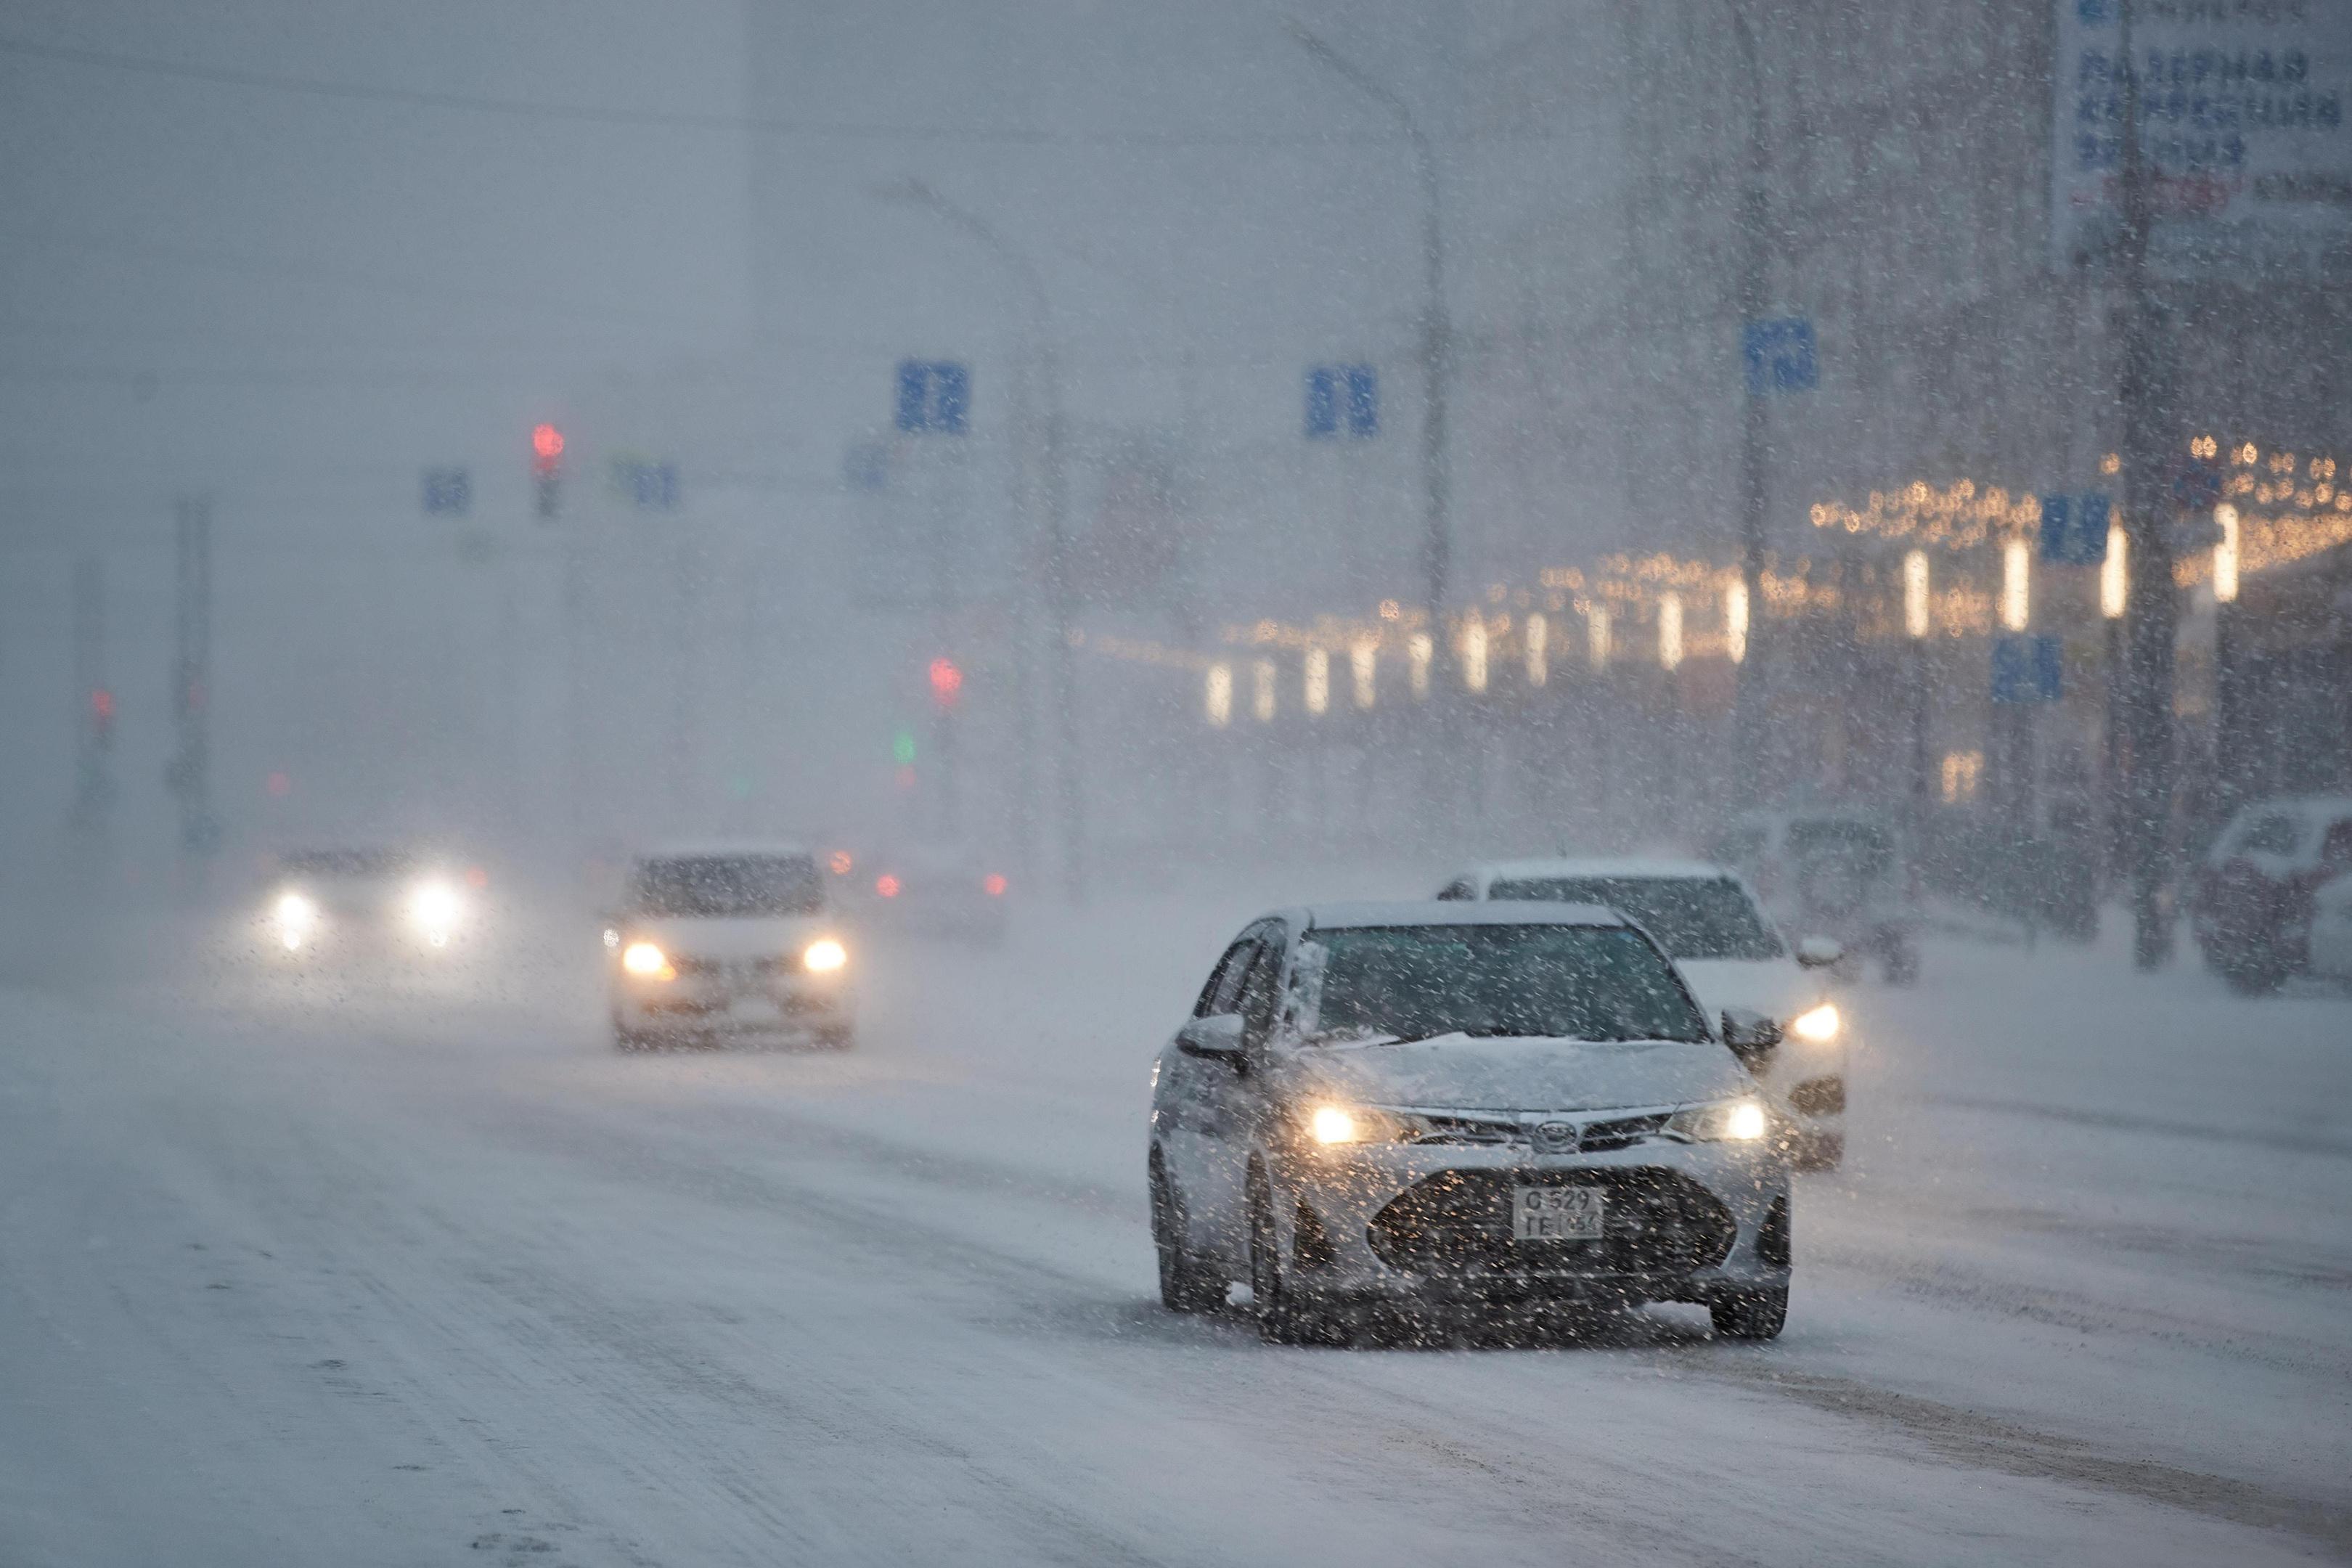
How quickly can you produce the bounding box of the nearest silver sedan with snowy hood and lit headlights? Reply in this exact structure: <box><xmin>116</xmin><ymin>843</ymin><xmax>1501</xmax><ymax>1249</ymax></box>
<box><xmin>1148</xmin><ymin>903</ymin><xmax>1790</xmax><ymax>1342</ymax></box>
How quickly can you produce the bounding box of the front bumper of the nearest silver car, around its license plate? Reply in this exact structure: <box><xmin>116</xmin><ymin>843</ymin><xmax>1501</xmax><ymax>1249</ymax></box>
<box><xmin>1270</xmin><ymin>1138</ymin><xmax>1790</xmax><ymax>1307</ymax></box>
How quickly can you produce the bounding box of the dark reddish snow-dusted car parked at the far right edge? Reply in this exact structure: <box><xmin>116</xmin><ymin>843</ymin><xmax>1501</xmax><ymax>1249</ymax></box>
<box><xmin>2189</xmin><ymin>795</ymin><xmax>2352</xmax><ymax>997</ymax></box>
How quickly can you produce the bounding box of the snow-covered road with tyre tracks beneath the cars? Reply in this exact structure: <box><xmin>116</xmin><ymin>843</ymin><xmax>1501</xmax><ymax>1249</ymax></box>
<box><xmin>0</xmin><ymin>898</ymin><xmax>2352</xmax><ymax>1568</ymax></box>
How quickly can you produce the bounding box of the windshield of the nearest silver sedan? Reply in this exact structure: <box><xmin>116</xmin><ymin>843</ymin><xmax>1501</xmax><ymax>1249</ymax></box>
<box><xmin>1312</xmin><ymin>926</ymin><xmax>1707</xmax><ymax>1039</ymax></box>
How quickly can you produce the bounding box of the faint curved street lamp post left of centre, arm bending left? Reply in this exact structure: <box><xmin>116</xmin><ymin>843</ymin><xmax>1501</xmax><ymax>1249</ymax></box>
<box><xmin>880</xmin><ymin>179</ymin><xmax>1087</xmax><ymax>900</ymax></box>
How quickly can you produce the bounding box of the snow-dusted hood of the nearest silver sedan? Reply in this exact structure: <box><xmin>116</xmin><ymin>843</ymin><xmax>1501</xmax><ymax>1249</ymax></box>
<box><xmin>1296</xmin><ymin>1034</ymin><xmax>1755</xmax><ymax>1110</ymax></box>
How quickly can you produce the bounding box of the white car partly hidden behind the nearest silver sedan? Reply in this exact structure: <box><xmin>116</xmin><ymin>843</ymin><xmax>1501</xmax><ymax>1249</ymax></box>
<box><xmin>1437</xmin><ymin>858</ymin><xmax>1853</xmax><ymax>1171</ymax></box>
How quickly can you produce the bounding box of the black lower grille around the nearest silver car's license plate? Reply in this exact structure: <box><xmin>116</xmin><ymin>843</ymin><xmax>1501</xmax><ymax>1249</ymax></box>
<box><xmin>1366</xmin><ymin>1166</ymin><xmax>1738</xmax><ymax>1276</ymax></box>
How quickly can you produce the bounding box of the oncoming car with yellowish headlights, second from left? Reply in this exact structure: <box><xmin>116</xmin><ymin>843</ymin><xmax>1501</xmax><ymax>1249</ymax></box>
<box><xmin>605</xmin><ymin>844</ymin><xmax>856</xmax><ymax>1051</ymax></box>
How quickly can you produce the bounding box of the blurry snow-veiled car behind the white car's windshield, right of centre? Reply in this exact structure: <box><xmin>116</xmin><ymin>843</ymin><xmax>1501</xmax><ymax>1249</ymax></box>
<box><xmin>1703</xmin><ymin>809</ymin><xmax>1919</xmax><ymax>985</ymax></box>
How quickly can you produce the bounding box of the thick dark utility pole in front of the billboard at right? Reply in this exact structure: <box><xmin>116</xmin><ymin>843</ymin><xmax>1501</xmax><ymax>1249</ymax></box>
<box><xmin>2117</xmin><ymin>0</ymin><xmax>2180</xmax><ymax>968</ymax></box>
